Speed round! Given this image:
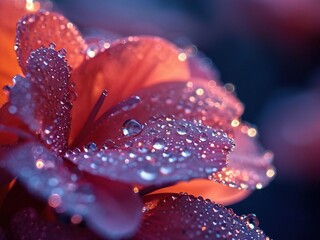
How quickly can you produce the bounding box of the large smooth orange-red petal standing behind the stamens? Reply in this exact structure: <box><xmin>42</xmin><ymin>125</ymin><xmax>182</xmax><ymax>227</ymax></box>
<box><xmin>72</xmin><ymin>37</ymin><xmax>189</xmax><ymax>141</ymax></box>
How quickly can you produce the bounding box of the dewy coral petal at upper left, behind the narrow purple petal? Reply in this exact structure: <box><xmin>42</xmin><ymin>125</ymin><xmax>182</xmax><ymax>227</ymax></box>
<box><xmin>16</xmin><ymin>11</ymin><xmax>87</xmax><ymax>74</ymax></box>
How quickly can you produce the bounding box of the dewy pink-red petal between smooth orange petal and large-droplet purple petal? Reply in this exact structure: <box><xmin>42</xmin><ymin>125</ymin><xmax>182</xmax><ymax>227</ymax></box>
<box><xmin>83</xmin><ymin>79</ymin><xmax>243</xmax><ymax>144</ymax></box>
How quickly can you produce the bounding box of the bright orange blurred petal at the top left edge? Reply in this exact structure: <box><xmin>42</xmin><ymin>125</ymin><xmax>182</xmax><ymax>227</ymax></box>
<box><xmin>0</xmin><ymin>0</ymin><xmax>26</xmax><ymax>106</ymax></box>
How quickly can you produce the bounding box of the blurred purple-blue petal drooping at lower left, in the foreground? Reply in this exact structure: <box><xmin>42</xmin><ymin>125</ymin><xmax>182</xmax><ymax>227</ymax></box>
<box><xmin>5</xmin><ymin>143</ymin><xmax>141</xmax><ymax>238</ymax></box>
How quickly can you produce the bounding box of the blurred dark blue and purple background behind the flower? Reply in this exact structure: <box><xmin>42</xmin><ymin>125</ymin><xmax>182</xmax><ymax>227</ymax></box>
<box><xmin>54</xmin><ymin>0</ymin><xmax>320</xmax><ymax>239</ymax></box>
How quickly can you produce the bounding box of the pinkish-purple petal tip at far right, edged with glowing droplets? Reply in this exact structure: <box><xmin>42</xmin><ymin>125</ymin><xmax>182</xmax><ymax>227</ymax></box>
<box><xmin>211</xmin><ymin>125</ymin><xmax>275</xmax><ymax>189</ymax></box>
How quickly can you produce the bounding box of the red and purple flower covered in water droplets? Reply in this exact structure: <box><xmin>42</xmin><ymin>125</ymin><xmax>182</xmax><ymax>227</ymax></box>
<box><xmin>0</xmin><ymin>1</ymin><xmax>274</xmax><ymax>239</ymax></box>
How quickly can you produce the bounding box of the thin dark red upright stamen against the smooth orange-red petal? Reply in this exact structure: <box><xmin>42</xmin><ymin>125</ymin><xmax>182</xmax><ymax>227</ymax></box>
<box><xmin>70</xmin><ymin>90</ymin><xmax>108</xmax><ymax>148</ymax></box>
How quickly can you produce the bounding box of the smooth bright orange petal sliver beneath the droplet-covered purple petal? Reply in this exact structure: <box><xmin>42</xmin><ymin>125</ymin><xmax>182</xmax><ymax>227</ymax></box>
<box><xmin>151</xmin><ymin>179</ymin><xmax>251</xmax><ymax>205</ymax></box>
